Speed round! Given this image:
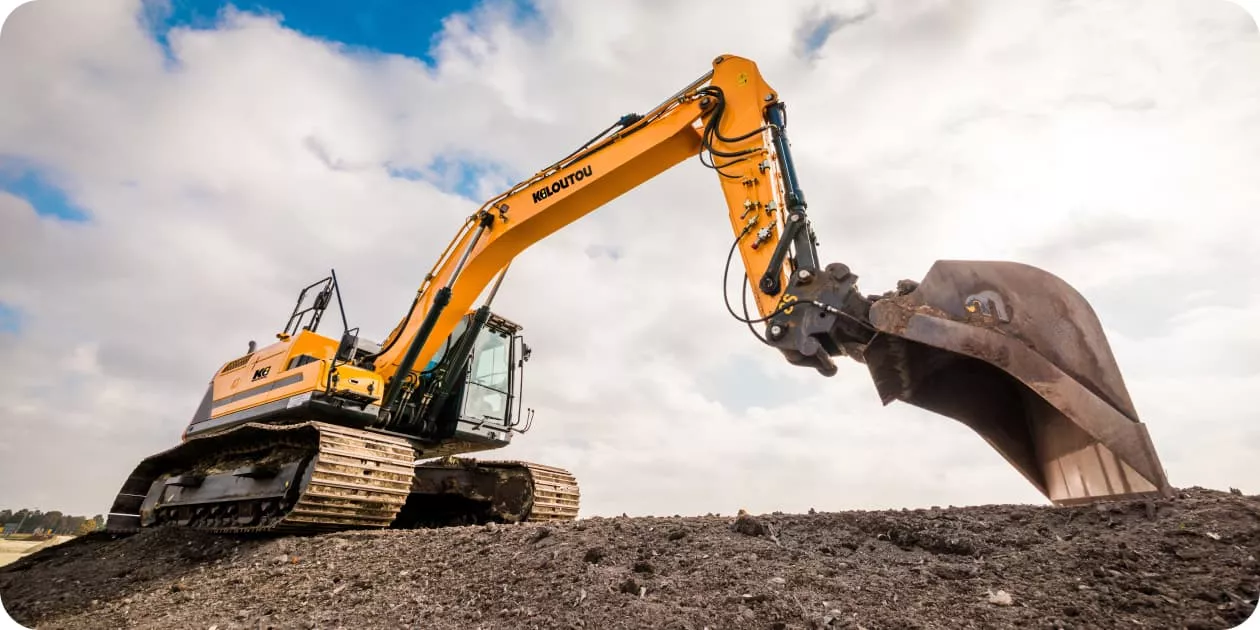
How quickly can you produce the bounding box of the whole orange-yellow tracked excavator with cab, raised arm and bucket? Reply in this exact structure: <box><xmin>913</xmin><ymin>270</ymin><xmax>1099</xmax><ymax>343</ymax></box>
<box><xmin>107</xmin><ymin>55</ymin><xmax>1173</xmax><ymax>534</ymax></box>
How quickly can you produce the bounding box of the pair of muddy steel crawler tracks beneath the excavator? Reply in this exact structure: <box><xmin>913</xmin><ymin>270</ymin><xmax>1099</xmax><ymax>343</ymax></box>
<box><xmin>106</xmin><ymin>421</ymin><xmax>580</xmax><ymax>534</ymax></box>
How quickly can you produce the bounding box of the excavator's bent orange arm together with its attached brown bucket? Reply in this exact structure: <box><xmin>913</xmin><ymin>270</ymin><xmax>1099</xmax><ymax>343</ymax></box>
<box><xmin>369</xmin><ymin>55</ymin><xmax>1171</xmax><ymax>504</ymax></box>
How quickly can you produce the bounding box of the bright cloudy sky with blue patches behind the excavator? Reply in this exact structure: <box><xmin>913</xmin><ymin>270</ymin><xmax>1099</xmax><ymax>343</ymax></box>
<box><xmin>0</xmin><ymin>0</ymin><xmax>1260</xmax><ymax>515</ymax></box>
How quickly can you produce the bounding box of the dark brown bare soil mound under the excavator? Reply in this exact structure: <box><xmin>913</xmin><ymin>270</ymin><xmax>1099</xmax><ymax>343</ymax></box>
<box><xmin>0</xmin><ymin>488</ymin><xmax>1260</xmax><ymax>630</ymax></box>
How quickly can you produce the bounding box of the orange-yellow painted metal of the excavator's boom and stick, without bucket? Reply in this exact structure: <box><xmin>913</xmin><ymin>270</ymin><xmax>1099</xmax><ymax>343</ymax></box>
<box><xmin>367</xmin><ymin>55</ymin><xmax>786</xmax><ymax>388</ymax></box>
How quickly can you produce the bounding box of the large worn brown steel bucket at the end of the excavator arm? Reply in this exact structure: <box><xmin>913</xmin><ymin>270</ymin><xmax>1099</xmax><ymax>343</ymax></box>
<box><xmin>864</xmin><ymin>261</ymin><xmax>1172</xmax><ymax>505</ymax></box>
